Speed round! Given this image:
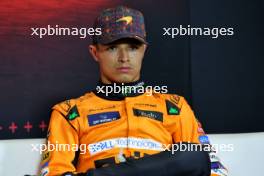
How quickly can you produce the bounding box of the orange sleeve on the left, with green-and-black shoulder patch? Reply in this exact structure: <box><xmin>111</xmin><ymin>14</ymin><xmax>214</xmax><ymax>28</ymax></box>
<box><xmin>40</xmin><ymin>100</ymin><xmax>79</xmax><ymax>176</ymax></box>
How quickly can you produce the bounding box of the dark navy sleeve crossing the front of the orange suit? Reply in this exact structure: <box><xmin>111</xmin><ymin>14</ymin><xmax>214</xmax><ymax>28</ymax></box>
<box><xmin>84</xmin><ymin>146</ymin><xmax>210</xmax><ymax>176</ymax></box>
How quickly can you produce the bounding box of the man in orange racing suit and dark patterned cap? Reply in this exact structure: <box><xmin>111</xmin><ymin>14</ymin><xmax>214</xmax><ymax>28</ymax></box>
<box><xmin>41</xmin><ymin>6</ymin><xmax>226</xmax><ymax>176</ymax></box>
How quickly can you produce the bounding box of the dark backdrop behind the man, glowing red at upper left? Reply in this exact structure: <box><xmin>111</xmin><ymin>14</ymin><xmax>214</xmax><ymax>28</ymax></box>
<box><xmin>0</xmin><ymin>0</ymin><xmax>264</xmax><ymax>139</ymax></box>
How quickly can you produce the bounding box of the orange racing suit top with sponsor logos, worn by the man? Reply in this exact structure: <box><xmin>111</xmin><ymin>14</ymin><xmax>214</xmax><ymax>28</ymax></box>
<box><xmin>41</xmin><ymin>81</ymin><xmax>227</xmax><ymax>176</ymax></box>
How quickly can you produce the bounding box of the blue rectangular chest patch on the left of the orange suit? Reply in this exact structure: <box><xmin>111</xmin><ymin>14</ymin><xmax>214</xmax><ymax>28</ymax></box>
<box><xmin>87</xmin><ymin>111</ymin><xmax>120</xmax><ymax>126</ymax></box>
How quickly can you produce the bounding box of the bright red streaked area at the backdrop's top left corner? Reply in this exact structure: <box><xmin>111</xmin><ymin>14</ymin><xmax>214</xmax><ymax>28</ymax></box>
<box><xmin>0</xmin><ymin>0</ymin><xmax>119</xmax><ymax>35</ymax></box>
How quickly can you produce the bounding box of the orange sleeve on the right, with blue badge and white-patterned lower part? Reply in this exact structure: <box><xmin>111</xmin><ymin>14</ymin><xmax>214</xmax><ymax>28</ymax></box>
<box><xmin>170</xmin><ymin>97</ymin><xmax>227</xmax><ymax>176</ymax></box>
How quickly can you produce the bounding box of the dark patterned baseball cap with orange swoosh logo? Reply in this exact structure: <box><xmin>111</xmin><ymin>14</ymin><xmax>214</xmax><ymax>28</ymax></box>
<box><xmin>93</xmin><ymin>6</ymin><xmax>147</xmax><ymax>44</ymax></box>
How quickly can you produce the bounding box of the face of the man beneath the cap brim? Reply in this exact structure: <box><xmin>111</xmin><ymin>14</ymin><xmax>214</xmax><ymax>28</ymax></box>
<box><xmin>90</xmin><ymin>39</ymin><xmax>146</xmax><ymax>83</ymax></box>
